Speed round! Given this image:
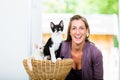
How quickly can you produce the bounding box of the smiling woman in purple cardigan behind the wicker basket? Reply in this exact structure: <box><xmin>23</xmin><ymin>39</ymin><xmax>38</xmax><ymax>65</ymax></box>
<box><xmin>61</xmin><ymin>15</ymin><xmax>103</xmax><ymax>80</ymax></box>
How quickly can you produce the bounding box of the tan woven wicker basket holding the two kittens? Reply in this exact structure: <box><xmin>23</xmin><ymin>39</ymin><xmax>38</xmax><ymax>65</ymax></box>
<box><xmin>23</xmin><ymin>59</ymin><xmax>73</xmax><ymax>80</ymax></box>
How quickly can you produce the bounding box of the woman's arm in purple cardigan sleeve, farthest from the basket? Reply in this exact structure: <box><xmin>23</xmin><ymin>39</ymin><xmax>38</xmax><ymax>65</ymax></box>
<box><xmin>92</xmin><ymin>49</ymin><xmax>103</xmax><ymax>80</ymax></box>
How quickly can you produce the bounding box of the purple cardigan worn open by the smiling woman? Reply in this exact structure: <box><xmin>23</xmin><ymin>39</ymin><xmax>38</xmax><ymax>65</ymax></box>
<box><xmin>60</xmin><ymin>41</ymin><xmax>103</xmax><ymax>80</ymax></box>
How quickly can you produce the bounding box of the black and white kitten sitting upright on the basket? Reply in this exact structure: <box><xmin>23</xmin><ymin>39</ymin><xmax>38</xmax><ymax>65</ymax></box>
<box><xmin>43</xmin><ymin>20</ymin><xmax>64</xmax><ymax>63</ymax></box>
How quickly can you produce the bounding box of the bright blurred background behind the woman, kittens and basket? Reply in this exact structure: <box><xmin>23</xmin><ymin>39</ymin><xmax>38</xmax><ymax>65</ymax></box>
<box><xmin>0</xmin><ymin>0</ymin><xmax>120</xmax><ymax>80</ymax></box>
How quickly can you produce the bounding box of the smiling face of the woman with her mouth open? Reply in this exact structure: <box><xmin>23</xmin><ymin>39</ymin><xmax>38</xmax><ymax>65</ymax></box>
<box><xmin>70</xmin><ymin>19</ymin><xmax>88</xmax><ymax>44</ymax></box>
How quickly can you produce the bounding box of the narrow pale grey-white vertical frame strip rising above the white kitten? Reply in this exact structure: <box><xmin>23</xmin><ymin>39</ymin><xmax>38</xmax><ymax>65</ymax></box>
<box><xmin>31</xmin><ymin>0</ymin><xmax>43</xmax><ymax>53</ymax></box>
